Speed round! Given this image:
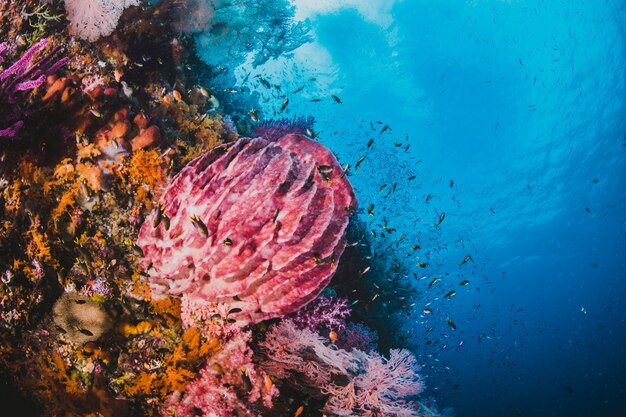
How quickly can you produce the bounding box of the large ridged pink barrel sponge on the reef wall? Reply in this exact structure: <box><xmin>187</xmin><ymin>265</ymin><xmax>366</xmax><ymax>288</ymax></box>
<box><xmin>137</xmin><ymin>134</ymin><xmax>357</xmax><ymax>324</ymax></box>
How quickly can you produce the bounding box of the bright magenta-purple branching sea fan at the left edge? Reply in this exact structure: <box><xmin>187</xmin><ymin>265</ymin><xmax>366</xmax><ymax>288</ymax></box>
<box><xmin>0</xmin><ymin>38</ymin><xmax>68</xmax><ymax>137</ymax></box>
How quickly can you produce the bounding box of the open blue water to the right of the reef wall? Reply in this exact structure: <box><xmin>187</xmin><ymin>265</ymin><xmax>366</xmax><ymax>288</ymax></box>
<box><xmin>225</xmin><ymin>0</ymin><xmax>626</xmax><ymax>417</ymax></box>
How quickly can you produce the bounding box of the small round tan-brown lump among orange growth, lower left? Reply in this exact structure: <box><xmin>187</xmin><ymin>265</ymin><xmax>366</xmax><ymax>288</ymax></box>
<box><xmin>52</xmin><ymin>292</ymin><xmax>111</xmax><ymax>345</ymax></box>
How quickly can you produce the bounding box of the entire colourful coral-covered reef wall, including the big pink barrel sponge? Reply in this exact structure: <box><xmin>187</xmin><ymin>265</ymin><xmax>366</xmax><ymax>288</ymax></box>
<box><xmin>0</xmin><ymin>0</ymin><xmax>448</xmax><ymax>417</ymax></box>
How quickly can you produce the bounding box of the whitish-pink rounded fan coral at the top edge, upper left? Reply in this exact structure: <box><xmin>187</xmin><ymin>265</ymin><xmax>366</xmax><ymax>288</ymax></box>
<box><xmin>65</xmin><ymin>0</ymin><xmax>140</xmax><ymax>42</ymax></box>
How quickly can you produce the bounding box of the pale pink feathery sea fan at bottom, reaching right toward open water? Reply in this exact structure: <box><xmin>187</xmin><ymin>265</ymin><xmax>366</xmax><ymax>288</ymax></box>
<box><xmin>260</xmin><ymin>319</ymin><xmax>423</xmax><ymax>417</ymax></box>
